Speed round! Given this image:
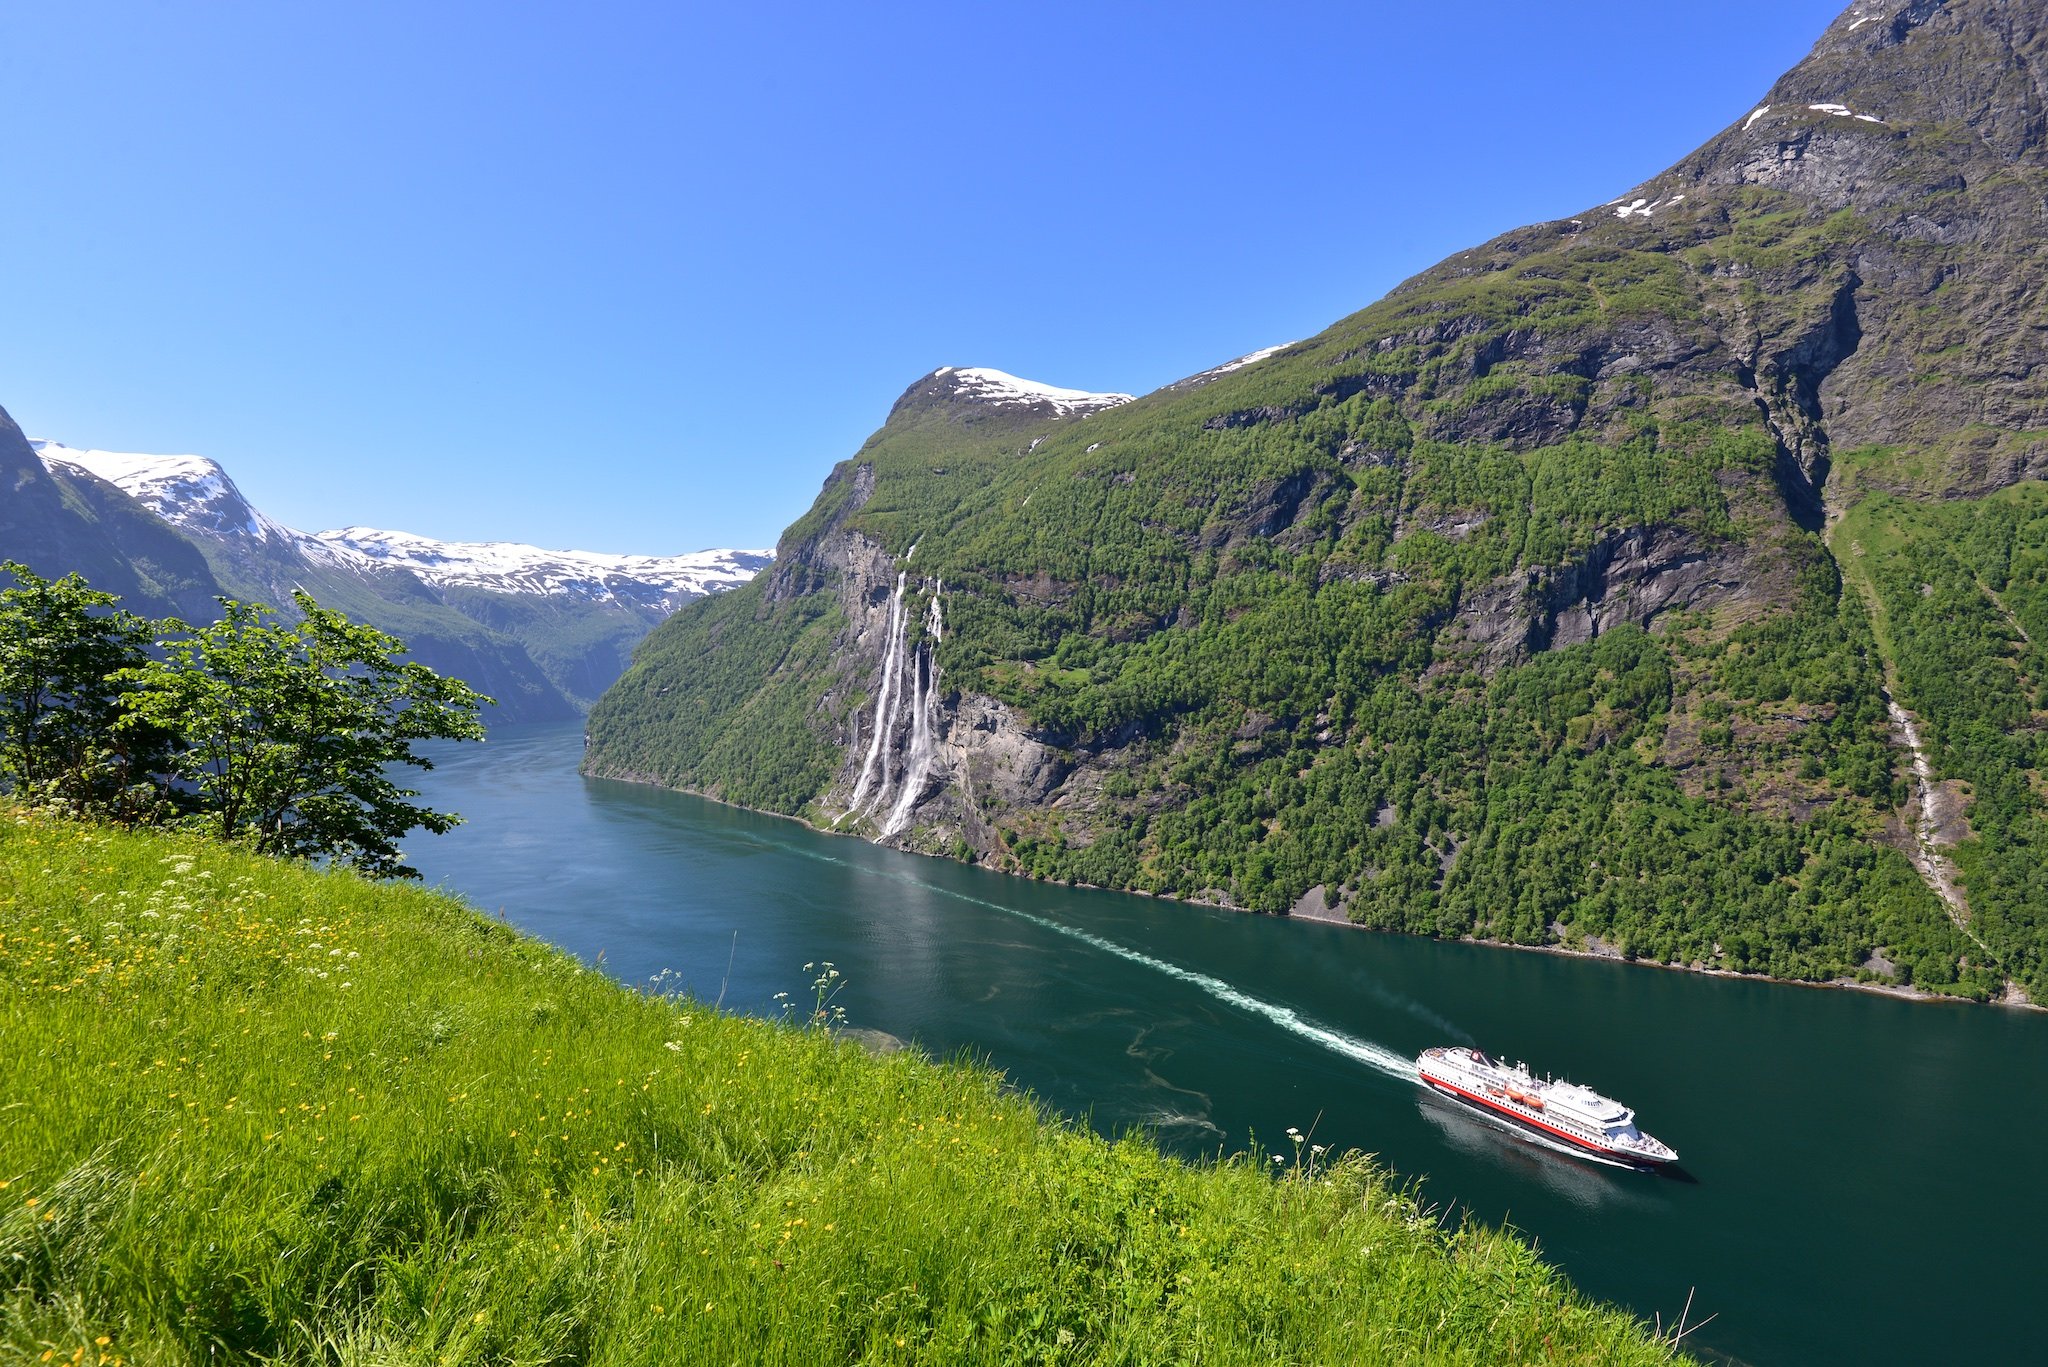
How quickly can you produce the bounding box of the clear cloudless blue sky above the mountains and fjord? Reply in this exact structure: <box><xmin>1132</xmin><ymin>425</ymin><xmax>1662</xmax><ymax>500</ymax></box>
<box><xmin>0</xmin><ymin>0</ymin><xmax>1841</xmax><ymax>553</ymax></box>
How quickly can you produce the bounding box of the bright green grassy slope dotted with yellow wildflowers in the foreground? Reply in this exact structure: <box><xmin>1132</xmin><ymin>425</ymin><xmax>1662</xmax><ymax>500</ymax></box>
<box><xmin>0</xmin><ymin>805</ymin><xmax>1673</xmax><ymax>1363</ymax></box>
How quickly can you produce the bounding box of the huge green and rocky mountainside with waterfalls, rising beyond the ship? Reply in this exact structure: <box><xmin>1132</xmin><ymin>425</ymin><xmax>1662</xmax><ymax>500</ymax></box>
<box><xmin>588</xmin><ymin>0</ymin><xmax>2048</xmax><ymax>998</ymax></box>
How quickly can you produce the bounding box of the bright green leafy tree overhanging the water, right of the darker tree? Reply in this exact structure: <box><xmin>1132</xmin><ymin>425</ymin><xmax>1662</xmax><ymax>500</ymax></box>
<box><xmin>127</xmin><ymin>592</ymin><xmax>489</xmax><ymax>877</ymax></box>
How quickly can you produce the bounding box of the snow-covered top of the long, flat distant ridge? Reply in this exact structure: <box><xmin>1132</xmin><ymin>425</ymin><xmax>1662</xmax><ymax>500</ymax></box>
<box><xmin>317</xmin><ymin>527</ymin><xmax>774</xmax><ymax>613</ymax></box>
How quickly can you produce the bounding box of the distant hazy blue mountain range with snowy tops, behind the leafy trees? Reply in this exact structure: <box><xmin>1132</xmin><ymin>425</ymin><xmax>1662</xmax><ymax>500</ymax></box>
<box><xmin>0</xmin><ymin>420</ymin><xmax>768</xmax><ymax>721</ymax></box>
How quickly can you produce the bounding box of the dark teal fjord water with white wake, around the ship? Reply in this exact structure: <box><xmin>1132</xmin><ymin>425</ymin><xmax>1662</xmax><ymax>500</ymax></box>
<box><xmin>410</xmin><ymin>726</ymin><xmax>2048</xmax><ymax>1363</ymax></box>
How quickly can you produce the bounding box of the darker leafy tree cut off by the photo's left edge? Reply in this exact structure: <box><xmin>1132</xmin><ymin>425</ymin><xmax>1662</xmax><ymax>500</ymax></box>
<box><xmin>0</xmin><ymin>560</ymin><xmax>170</xmax><ymax>820</ymax></box>
